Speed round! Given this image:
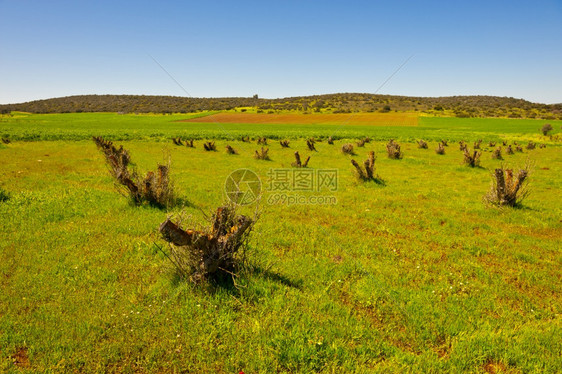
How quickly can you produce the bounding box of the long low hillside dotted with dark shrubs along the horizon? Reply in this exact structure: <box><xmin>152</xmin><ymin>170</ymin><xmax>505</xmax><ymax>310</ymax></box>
<box><xmin>0</xmin><ymin>93</ymin><xmax>562</xmax><ymax>119</ymax></box>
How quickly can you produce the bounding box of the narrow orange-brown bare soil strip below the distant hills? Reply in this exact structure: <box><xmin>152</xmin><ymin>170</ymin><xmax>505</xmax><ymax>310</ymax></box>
<box><xmin>179</xmin><ymin>113</ymin><xmax>418</xmax><ymax>126</ymax></box>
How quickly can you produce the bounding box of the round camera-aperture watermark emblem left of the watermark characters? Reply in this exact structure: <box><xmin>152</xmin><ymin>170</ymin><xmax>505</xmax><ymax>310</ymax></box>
<box><xmin>224</xmin><ymin>169</ymin><xmax>261</xmax><ymax>205</ymax></box>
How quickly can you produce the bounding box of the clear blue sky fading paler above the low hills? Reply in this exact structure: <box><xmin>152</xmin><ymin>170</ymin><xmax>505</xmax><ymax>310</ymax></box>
<box><xmin>0</xmin><ymin>0</ymin><xmax>562</xmax><ymax>103</ymax></box>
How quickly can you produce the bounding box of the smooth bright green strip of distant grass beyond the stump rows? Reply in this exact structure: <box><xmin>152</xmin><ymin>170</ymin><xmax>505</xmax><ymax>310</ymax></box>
<box><xmin>0</xmin><ymin>112</ymin><xmax>562</xmax><ymax>142</ymax></box>
